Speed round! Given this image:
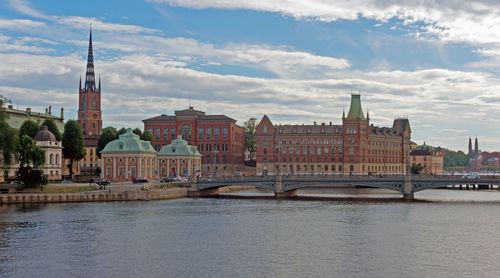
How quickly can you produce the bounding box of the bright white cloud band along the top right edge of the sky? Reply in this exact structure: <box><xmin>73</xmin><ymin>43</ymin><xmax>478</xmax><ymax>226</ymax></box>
<box><xmin>149</xmin><ymin>0</ymin><xmax>500</xmax><ymax>59</ymax></box>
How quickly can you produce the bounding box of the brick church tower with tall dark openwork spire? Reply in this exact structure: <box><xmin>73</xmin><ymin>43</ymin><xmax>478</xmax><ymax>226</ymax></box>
<box><xmin>78</xmin><ymin>29</ymin><xmax>102</xmax><ymax>147</ymax></box>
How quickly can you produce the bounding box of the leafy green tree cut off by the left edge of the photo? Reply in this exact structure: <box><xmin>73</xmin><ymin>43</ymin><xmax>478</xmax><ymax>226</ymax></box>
<box><xmin>0</xmin><ymin>98</ymin><xmax>17</xmax><ymax>169</ymax></box>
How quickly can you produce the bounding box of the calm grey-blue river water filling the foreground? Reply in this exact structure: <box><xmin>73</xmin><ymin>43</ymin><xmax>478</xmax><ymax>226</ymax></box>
<box><xmin>0</xmin><ymin>189</ymin><xmax>500</xmax><ymax>277</ymax></box>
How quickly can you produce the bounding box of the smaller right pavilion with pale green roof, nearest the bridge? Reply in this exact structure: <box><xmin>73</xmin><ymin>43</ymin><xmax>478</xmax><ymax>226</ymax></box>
<box><xmin>158</xmin><ymin>135</ymin><xmax>203</xmax><ymax>177</ymax></box>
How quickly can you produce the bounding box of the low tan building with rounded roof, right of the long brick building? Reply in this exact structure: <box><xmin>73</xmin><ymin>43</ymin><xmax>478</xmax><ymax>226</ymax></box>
<box><xmin>410</xmin><ymin>143</ymin><xmax>444</xmax><ymax>175</ymax></box>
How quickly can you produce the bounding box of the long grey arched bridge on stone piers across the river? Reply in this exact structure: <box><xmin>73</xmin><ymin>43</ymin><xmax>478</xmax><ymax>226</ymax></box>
<box><xmin>190</xmin><ymin>175</ymin><xmax>500</xmax><ymax>201</ymax></box>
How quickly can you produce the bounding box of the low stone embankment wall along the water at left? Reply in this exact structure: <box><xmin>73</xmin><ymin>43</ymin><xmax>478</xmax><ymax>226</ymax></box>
<box><xmin>0</xmin><ymin>188</ymin><xmax>188</xmax><ymax>204</ymax></box>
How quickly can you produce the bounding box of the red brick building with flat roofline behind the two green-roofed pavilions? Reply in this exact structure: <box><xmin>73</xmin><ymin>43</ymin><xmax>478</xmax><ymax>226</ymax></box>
<box><xmin>143</xmin><ymin>107</ymin><xmax>245</xmax><ymax>176</ymax></box>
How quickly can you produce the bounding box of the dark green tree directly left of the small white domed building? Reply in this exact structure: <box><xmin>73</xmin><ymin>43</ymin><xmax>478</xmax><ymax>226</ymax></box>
<box><xmin>17</xmin><ymin>134</ymin><xmax>46</xmax><ymax>187</ymax></box>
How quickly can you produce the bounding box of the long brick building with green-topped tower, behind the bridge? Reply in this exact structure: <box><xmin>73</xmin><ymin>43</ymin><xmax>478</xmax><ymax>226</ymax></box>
<box><xmin>256</xmin><ymin>95</ymin><xmax>411</xmax><ymax>175</ymax></box>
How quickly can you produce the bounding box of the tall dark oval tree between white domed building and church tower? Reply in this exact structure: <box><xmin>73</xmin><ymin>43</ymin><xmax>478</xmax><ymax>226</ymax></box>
<box><xmin>62</xmin><ymin>120</ymin><xmax>85</xmax><ymax>178</ymax></box>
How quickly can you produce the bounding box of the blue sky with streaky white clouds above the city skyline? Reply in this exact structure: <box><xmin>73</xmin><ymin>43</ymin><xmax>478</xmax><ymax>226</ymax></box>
<box><xmin>0</xmin><ymin>0</ymin><xmax>500</xmax><ymax>151</ymax></box>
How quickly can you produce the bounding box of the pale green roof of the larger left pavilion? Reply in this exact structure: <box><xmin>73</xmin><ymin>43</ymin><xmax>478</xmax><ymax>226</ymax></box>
<box><xmin>101</xmin><ymin>128</ymin><xmax>156</xmax><ymax>153</ymax></box>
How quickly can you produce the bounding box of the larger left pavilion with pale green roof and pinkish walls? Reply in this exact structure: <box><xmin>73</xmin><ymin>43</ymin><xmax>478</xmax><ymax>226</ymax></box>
<box><xmin>101</xmin><ymin>129</ymin><xmax>157</xmax><ymax>182</ymax></box>
